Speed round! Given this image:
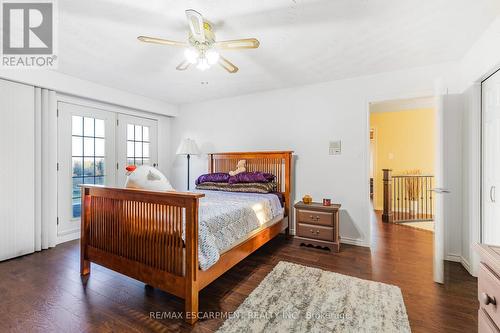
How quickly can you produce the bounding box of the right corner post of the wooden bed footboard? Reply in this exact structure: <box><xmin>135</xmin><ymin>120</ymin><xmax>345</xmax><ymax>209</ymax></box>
<box><xmin>184</xmin><ymin>198</ymin><xmax>199</xmax><ymax>324</ymax></box>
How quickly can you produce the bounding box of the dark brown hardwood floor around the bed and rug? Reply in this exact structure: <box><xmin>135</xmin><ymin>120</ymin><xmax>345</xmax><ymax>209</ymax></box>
<box><xmin>0</xmin><ymin>211</ymin><xmax>478</xmax><ymax>332</ymax></box>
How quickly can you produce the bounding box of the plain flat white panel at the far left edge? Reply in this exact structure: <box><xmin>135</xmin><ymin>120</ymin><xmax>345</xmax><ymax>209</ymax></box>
<box><xmin>0</xmin><ymin>80</ymin><xmax>35</xmax><ymax>260</ymax></box>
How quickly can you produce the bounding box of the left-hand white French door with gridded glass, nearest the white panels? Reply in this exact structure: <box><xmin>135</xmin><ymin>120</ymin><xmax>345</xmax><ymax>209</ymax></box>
<box><xmin>57</xmin><ymin>102</ymin><xmax>116</xmax><ymax>239</ymax></box>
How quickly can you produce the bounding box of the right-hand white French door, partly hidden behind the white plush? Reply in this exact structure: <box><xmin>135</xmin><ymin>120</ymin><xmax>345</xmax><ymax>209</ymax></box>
<box><xmin>116</xmin><ymin>114</ymin><xmax>158</xmax><ymax>186</ymax></box>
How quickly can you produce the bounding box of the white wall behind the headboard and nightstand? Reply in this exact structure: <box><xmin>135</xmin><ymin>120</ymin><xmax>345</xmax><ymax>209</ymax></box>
<box><xmin>170</xmin><ymin>63</ymin><xmax>458</xmax><ymax>246</ymax></box>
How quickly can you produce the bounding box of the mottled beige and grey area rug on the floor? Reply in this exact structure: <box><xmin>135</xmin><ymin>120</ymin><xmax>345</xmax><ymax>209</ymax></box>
<box><xmin>217</xmin><ymin>261</ymin><xmax>411</xmax><ymax>333</ymax></box>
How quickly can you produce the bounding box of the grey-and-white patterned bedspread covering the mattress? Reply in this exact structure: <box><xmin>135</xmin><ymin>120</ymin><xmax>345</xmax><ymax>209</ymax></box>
<box><xmin>197</xmin><ymin>191</ymin><xmax>284</xmax><ymax>270</ymax></box>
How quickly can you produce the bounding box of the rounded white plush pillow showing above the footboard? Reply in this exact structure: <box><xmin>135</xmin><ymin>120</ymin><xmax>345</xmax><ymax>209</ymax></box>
<box><xmin>125</xmin><ymin>165</ymin><xmax>175</xmax><ymax>191</ymax></box>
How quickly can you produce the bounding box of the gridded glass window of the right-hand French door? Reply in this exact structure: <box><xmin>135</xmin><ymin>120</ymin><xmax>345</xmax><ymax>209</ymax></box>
<box><xmin>127</xmin><ymin>124</ymin><xmax>150</xmax><ymax>166</ymax></box>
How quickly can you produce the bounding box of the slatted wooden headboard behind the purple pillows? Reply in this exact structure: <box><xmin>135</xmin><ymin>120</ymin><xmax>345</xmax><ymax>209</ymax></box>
<box><xmin>208</xmin><ymin>151</ymin><xmax>293</xmax><ymax>216</ymax></box>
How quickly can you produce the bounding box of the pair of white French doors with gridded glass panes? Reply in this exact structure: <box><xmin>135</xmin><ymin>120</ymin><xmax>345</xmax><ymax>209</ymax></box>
<box><xmin>57</xmin><ymin>102</ymin><xmax>158</xmax><ymax>241</ymax></box>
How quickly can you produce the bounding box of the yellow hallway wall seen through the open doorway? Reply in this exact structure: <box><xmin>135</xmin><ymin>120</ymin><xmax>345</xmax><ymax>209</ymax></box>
<box><xmin>370</xmin><ymin>109</ymin><xmax>436</xmax><ymax>210</ymax></box>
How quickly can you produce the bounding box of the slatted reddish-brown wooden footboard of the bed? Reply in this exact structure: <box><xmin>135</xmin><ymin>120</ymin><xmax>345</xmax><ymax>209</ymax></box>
<box><xmin>81</xmin><ymin>185</ymin><xmax>204</xmax><ymax>322</ymax></box>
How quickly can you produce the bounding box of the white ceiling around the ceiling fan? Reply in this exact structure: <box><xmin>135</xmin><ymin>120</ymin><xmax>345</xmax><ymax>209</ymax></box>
<box><xmin>54</xmin><ymin>0</ymin><xmax>500</xmax><ymax>104</ymax></box>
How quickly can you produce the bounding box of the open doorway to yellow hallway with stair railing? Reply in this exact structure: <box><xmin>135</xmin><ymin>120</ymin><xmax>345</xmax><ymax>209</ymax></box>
<box><xmin>368</xmin><ymin>97</ymin><xmax>446</xmax><ymax>282</ymax></box>
